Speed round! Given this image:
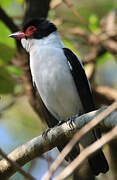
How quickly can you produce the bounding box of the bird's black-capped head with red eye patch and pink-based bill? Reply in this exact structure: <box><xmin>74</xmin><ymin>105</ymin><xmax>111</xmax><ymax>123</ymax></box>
<box><xmin>9</xmin><ymin>18</ymin><xmax>57</xmax><ymax>40</ymax></box>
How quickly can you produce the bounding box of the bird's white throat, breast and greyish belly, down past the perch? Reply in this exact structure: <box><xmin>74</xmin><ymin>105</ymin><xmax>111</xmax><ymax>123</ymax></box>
<box><xmin>21</xmin><ymin>32</ymin><xmax>95</xmax><ymax>151</ymax></box>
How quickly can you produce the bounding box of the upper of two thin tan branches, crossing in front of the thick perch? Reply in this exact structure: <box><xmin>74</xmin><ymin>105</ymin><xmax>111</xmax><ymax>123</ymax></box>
<box><xmin>44</xmin><ymin>102</ymin><xmax>117</xmax><ymax>180</ymax></box>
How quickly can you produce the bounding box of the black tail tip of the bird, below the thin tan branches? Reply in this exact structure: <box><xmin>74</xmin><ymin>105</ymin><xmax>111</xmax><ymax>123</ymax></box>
<box><xmin>89</xmin><ymin>150</ymin><xmax>109</xmax><ymax>176</ymax></box>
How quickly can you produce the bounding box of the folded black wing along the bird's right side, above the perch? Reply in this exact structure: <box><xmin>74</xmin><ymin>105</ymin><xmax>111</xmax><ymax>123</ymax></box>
<box><xmin>63</xmin><ymin>48</ymin><xmax>95</xmax><ymax>113</ymax></box>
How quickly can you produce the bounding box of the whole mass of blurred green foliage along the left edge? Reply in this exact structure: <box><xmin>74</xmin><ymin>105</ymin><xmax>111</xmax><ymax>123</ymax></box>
<box><xmin>0</xmin><ymin>22</ymin><xmax>18</xmax><ymax>94</ymax></box>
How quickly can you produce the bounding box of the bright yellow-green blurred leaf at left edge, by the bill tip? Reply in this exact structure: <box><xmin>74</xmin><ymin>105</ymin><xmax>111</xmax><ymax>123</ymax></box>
<box><xmin>0</xmin><ymin>22</ymin><xmax>16</xmax><ymax>48</ymax></box>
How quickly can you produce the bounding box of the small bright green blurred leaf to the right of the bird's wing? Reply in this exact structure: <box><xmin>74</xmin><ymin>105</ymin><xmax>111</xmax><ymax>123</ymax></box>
<box><xmin>96</xmin><ymin>52</ymin><xmax>114</xmax><ymax>64</ymax></box>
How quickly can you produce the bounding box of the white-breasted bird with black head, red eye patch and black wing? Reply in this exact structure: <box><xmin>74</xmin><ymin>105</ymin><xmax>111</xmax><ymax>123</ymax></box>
<box><xmin>9</xmin><ymin>18</ymin><xmax>109</xmax><ymax>176</ymax></box>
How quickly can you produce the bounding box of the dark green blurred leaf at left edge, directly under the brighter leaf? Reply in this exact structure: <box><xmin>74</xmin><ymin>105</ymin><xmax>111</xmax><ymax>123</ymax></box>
<box><xmin>0</xmin><ymin>43</ymin><xmax>15</xmax><ymax>66</ymax></box>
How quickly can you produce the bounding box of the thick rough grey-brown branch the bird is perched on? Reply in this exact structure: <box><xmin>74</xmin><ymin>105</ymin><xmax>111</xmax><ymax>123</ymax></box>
<box><xmin>0</xmin><ymin>102</ymin><xmax>117</xmax><ymax>179</ymax></box>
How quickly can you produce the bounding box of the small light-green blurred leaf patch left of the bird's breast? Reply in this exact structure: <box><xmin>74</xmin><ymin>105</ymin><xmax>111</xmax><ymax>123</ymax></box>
<box><xmin>5</xmin><ymin>65</ymin><xmax>22</xmax><ymax>76</ymax></box>
